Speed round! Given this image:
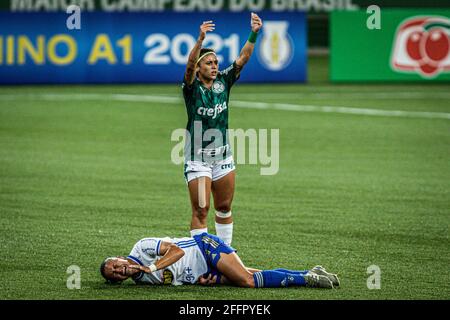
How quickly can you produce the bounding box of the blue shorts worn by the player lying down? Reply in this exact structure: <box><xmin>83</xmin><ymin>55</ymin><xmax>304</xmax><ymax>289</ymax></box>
<box><xmin>194</xmin><ymin>232</ymin><xmax>236</xmax><ymax>272</ymax></box>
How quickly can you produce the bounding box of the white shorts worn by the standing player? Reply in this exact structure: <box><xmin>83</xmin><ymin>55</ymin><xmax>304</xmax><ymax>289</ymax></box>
<box><xmin>184</xmin><ymin>156</ymin><xmax>235</xmax><ymax>183</ymax></box>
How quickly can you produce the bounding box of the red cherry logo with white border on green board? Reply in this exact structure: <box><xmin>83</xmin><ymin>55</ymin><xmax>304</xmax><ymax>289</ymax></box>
<box><xmin>391</xmin><ymin>16</ymin><xmax>450</xmax><ymax>78</ymax></box>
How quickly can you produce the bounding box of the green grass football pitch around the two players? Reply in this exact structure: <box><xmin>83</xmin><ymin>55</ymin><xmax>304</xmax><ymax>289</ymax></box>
<box><xmin>0</xmin><ymin>58</ymin><xmax>450</xmax><ymax>300</ymax></box>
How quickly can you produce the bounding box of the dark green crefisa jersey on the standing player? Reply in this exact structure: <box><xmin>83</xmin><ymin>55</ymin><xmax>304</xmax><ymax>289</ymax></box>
<box><xmin>182</xmin><ymin>62</ymin><xmax>239</xmax><ymax>162</ymax></box>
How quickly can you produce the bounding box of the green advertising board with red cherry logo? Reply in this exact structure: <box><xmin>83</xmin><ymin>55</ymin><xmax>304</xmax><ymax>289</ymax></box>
<box><xmin>330</xmin><ymin>9</ymin><xmax>450</xmax><ymax>82</ymax></box>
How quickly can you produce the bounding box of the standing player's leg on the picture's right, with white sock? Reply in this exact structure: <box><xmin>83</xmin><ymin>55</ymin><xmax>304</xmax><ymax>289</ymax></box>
<box><xmin>211</xmin><ymin>164</ymin><xmax>235</xmax><ymax>245</ymax></box>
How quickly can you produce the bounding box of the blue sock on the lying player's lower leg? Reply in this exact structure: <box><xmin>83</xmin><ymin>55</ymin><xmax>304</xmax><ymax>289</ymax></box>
<box><xmin>253</xmin><ymin>270</ymin><xmax>306</xmax><ymax>288</ymax></box>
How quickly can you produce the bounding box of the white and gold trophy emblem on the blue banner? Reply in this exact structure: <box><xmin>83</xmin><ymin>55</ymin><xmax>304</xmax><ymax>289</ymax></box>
<box><xmin>258</xmin><ymin>21</ymin><xmax>294</xmax><ymax>71</ymax></box>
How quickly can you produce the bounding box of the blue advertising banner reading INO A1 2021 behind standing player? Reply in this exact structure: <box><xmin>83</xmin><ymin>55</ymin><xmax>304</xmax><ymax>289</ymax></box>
<box><xmin>0</xmin><ymin>12</ymin><xmax>307</xmax><ymax>84</ymax></box>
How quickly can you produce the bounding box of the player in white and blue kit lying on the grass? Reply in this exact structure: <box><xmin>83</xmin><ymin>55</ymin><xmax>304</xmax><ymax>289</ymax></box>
<box><xmin>100</xmin><ymin>233</ymin><xmax>339</xmax><ymax>289</ymax></box>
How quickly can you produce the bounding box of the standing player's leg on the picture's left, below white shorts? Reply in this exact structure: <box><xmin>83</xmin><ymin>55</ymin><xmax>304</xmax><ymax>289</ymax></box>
<box><xmin>188</xmin><ymin>175</ymin><xmax>211</xmax><ymax>237</ymax></box>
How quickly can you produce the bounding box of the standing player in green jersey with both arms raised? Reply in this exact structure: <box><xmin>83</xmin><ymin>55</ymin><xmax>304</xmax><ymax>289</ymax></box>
<box><xmin>182</xmin><ymin>13</ymin><xmax>262</xmax><ymax>244</ymax></box>
